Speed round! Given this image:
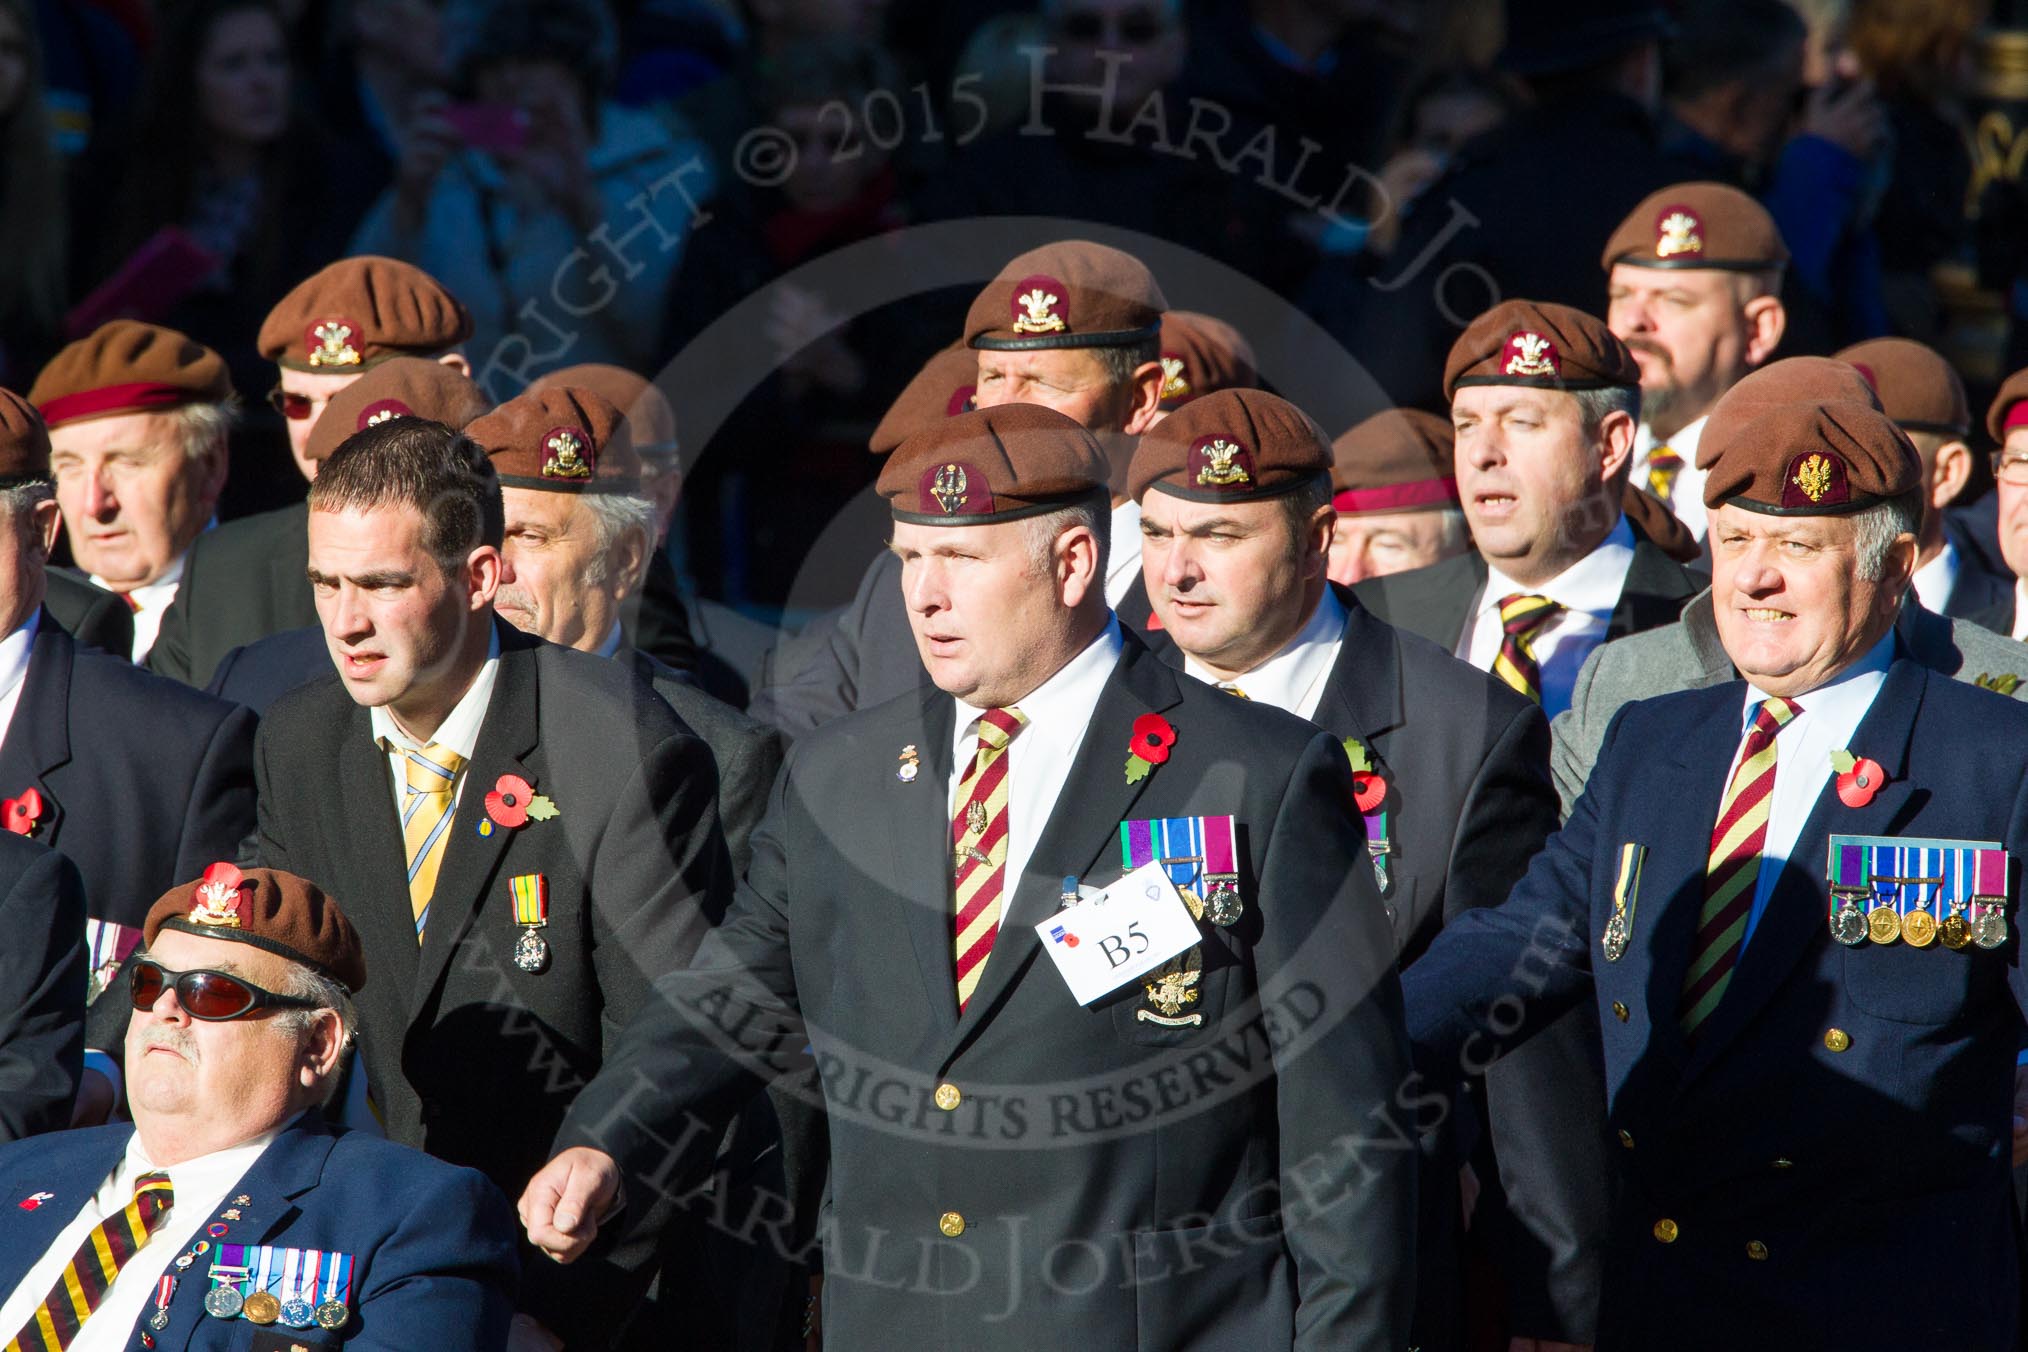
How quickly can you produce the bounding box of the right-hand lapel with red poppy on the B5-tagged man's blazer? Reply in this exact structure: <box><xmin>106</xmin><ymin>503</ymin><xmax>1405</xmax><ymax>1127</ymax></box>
<box><xmin>945</xmin><ymin>632</ymin><xmax>1188</xmax><ymax>1056</ymax></box>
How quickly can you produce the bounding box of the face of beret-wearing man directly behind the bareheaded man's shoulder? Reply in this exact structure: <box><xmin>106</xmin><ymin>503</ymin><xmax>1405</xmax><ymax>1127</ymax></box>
<box><xmin>493</xmin><ymin>486</ymin><xmax>639</xmax><ymax>653</ymax></box>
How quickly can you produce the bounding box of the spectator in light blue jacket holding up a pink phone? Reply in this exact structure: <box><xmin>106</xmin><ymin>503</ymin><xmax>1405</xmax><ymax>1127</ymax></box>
<box><xmin>353</xmin><ymin>0</ymin><xmax>710</xmax><ymax>397</ymax></box>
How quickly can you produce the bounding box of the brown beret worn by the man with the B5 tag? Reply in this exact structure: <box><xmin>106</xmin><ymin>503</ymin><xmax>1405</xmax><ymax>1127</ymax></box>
<box><xmin>876</xmin><ymin>403</ymin><xmax>1111</xmax><ymax>525</ymax></box>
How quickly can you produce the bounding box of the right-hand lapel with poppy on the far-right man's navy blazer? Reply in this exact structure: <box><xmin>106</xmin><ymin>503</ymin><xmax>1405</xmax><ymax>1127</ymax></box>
<box><xmin>1683</xmin><ymin>661</ymin><xmax>1929</xmax><ymax>1080</ymax></box>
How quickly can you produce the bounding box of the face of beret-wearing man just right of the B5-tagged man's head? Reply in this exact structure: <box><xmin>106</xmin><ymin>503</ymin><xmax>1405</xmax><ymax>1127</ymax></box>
<box><xmin>1142</xmin><ymin>489</ymin><xmax>1330</xmax><ymax>677</ymax></box>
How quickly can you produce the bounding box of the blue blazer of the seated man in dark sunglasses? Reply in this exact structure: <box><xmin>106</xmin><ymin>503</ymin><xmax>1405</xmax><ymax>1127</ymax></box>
<box><xmin>0</xmin><ymin>1113</ymin><xmax>517</xmax><ymax>1352</ymax></box>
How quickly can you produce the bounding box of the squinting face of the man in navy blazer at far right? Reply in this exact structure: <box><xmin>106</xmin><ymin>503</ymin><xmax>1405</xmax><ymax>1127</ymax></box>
<box><xmin>1710</xmin><ymin>503</ymin><xmax>1916</xmax><ymax>695</ymax></box>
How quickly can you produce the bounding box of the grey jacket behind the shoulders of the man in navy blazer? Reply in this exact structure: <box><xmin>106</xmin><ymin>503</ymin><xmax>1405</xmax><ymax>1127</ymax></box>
<box><xmin>1549</xmin><ymin>588</ymin><xmax>2028</xmax><ymax>819</ymax></box>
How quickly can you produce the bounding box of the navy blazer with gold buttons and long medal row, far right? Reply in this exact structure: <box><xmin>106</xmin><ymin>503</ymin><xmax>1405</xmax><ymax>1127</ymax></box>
<box><xmin>1403</xmin><ymin>659</ymin><xmax>2028</xmax><ymax>1352</ymax></box>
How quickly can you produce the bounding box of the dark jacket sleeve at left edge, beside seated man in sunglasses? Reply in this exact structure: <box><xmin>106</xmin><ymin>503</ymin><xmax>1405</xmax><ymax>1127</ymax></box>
<box><xmin>0</xmin><ymin>831</ymin><xmax>85</xmax><ymax>1143</ymax></box>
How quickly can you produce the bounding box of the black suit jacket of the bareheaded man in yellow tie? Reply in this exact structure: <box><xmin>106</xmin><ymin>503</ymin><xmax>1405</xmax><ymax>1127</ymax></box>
<box><xmin>256</xmin><ymin>624</ymin><xmax>728</xmax><ymax>1346</ymax></box>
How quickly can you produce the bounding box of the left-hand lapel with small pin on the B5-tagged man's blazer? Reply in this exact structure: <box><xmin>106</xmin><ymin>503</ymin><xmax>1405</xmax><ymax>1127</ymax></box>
<box><xmin>880</xmin><ymin>687</ymin><xmax>957</xmax><ymax>1038</ymax></box>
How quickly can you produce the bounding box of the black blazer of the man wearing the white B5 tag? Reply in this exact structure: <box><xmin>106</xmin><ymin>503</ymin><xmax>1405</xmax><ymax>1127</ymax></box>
<box><xmin>560</xmin><ymin>636</ymin><xmax>1416</xmax><ymax>1352</ymax></box>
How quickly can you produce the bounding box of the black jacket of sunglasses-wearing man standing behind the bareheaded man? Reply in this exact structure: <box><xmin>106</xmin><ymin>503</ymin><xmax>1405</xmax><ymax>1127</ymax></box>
<box><xmin>148</xmin><ymin>503</ymin><xmax>316</xmax><ymax>687</ymax></box>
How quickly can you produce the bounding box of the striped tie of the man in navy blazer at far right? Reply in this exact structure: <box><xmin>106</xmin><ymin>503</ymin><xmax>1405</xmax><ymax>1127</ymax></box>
<box><xmin>1675</xmin><ymin>695</ymin><xmax>1803</xmax><ymax>1038</ymax></box>
